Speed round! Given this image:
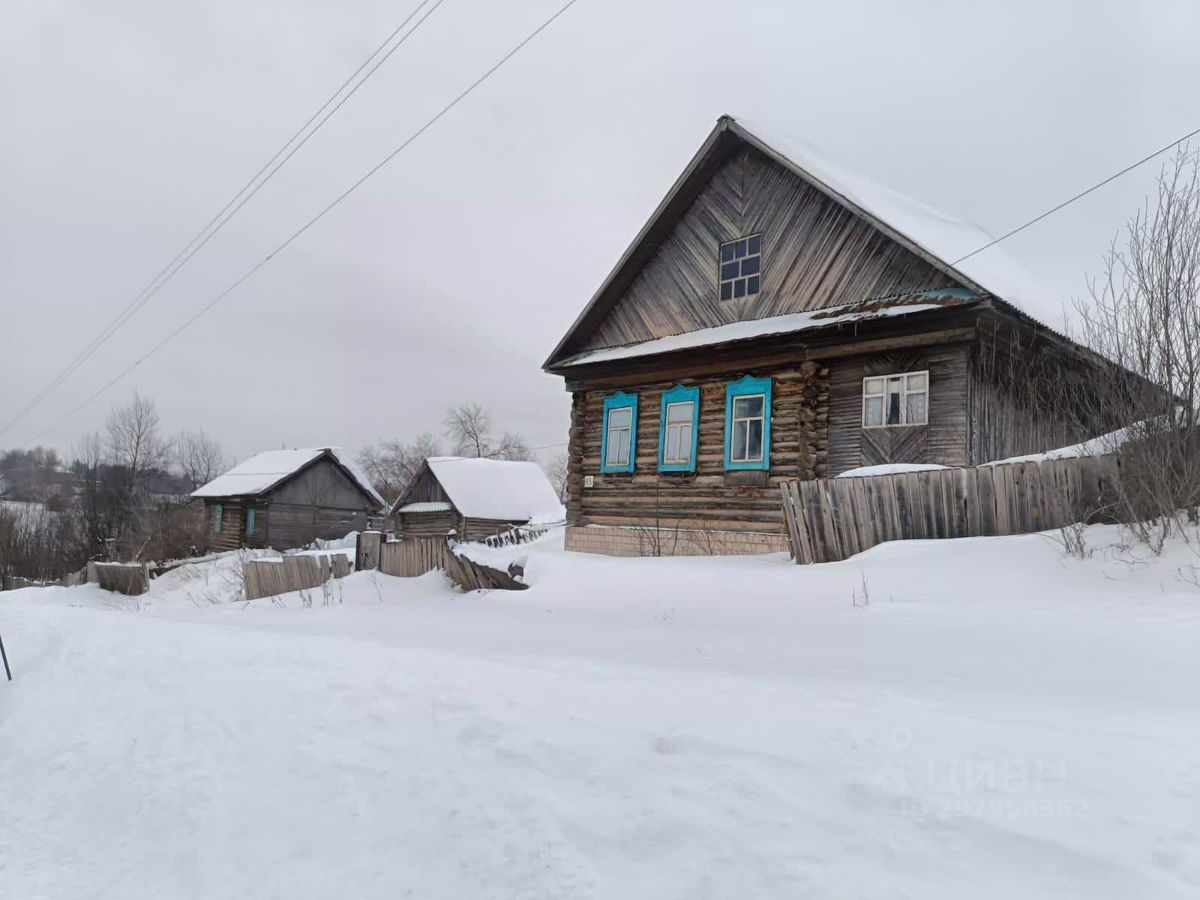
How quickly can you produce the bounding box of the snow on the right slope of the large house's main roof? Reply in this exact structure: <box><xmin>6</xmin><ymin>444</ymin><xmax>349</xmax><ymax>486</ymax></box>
<box><xmin>733</xmin><ymin>119</ymin><xmax>1062</xmax><ymax>323</ymax></box>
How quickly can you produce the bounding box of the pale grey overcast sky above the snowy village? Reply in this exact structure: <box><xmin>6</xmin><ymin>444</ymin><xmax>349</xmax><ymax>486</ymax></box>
<box><xmin>0</xmin><ymin>0</ymin><xmax>1200</xmax><ymax>458</ymax></box>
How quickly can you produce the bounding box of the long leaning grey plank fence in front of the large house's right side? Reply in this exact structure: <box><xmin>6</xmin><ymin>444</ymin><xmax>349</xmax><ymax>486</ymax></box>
<box><xmin>780</xmin><ymin>456</ymin><xmax>1120</xmax><ymax>563</ymax></box>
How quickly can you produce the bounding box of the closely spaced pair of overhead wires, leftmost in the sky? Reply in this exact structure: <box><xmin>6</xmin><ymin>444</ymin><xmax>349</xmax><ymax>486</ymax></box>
<box><xmin>0</xmin><ymin>0</ymin><xmax>445</xmax><ymax>434</ymax></box>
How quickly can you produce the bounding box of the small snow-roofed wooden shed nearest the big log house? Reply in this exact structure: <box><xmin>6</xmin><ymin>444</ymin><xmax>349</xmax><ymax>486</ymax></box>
<box><xmin>391</xmin><ymin>456</ymin><xmax>565</xmax><ymax>541</ymax></box>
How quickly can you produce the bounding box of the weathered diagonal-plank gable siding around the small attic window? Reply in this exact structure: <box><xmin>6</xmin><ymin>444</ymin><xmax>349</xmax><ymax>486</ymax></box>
<box><xmin>568</xmin><ymin>148</ymin><xmax>958</xmax><ymax>352</ymax></box>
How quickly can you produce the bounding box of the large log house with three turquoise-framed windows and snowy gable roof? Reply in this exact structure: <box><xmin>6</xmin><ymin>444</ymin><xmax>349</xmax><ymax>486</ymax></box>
<box><xmin>545</xmin><ymin>116</ymin><xmax>1123</xmax><ymax>554</ymax></box>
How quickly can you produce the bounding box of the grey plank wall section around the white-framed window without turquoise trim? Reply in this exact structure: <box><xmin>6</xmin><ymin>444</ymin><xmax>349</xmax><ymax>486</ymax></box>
<box><xmin>828</xmin><ymin>343</ymin><xmax>971</xmax><ymax>475</ymax></box>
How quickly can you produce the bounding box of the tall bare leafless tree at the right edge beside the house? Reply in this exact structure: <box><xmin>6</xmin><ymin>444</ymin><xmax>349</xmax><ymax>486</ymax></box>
<box><xmin>1076</xmin><ymin>149</ymin><xmax>1200</xmax><ymax>550</ymax></box>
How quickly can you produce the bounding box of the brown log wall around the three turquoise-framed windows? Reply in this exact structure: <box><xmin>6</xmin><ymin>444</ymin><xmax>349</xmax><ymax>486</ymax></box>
<box><xmin>568</xmin><ymin>364</ymin><xmax>826</xmax><ymax>534</ymax></box>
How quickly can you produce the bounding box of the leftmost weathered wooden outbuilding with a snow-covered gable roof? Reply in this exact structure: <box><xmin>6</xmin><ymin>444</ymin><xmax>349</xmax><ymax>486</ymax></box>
<box><xmin>192</xmin><ymin>446</ymin><xmax>386</xmax><ymax>551</ymax></box>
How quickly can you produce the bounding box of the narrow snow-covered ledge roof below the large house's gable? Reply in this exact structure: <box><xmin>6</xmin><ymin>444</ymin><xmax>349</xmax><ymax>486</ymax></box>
<box><xmin>558</xmin><ymin>302</ymin><xmax>947</xmax><ymax>366</ymax></box>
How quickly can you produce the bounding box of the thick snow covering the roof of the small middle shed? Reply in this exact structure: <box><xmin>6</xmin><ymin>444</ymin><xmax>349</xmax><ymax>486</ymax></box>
<box><xmin>426</xmin><ymin>456</ymin><xmax>566</xmax><ymax>522</ymax></box>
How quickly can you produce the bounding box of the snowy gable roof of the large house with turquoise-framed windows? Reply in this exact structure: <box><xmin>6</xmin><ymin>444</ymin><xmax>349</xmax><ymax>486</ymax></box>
<box><xmin>544</xmin><ymin>115</ymin><xmax>1057</xmax><ymax>368</ymax></box>
